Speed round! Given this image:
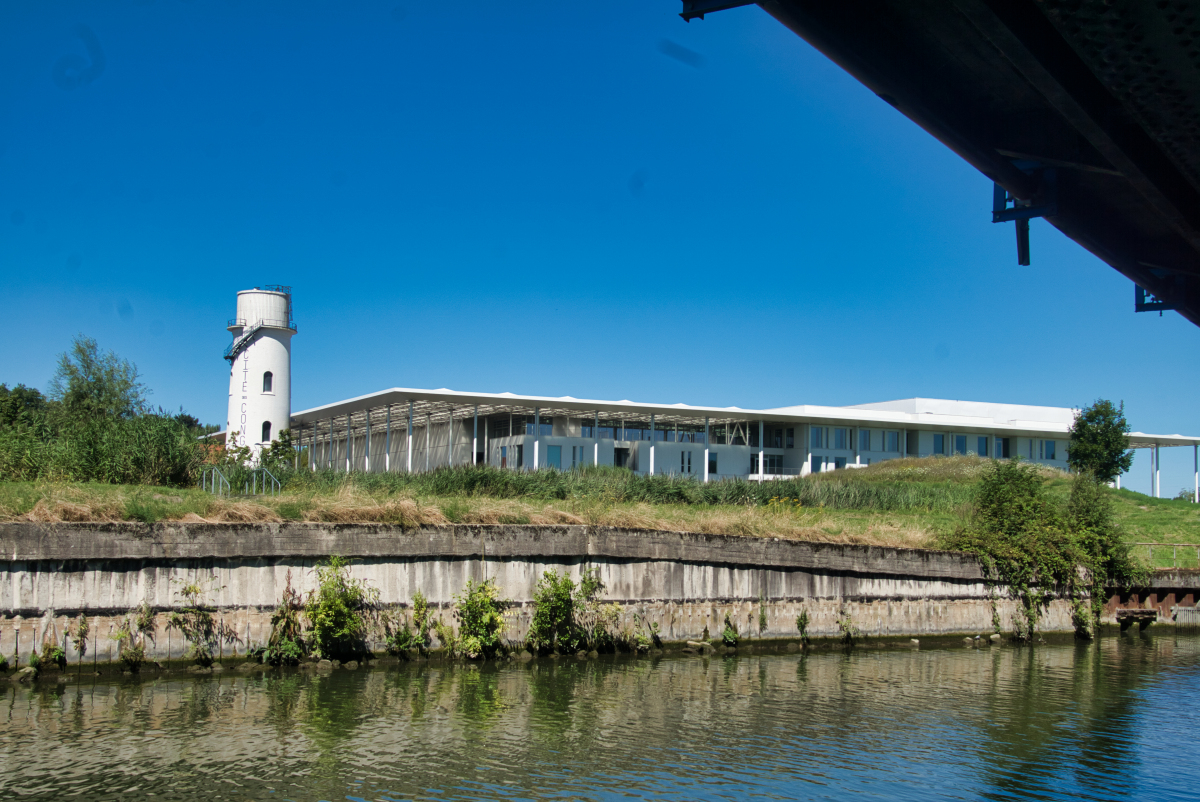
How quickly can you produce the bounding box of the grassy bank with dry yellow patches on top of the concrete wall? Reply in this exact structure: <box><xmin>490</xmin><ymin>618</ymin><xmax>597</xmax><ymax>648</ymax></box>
<box><xmin>0</xmin><ymin>457</ymin><xmax>1200</xmax><ymax>557</ymax></box>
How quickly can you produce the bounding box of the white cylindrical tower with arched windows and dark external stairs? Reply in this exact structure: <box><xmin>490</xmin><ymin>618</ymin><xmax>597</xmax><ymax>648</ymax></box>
<box><xmin>224</xmin><ymin>285</ymin><xmax>296</xmax><ymax>456</ymax></box>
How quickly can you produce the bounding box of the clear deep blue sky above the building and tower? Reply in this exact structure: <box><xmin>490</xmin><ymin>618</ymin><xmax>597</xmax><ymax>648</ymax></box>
<box><xmin>0</xmin><ymin>0</ymin><xmax>1200</xmax><ymax>496</ymax></box>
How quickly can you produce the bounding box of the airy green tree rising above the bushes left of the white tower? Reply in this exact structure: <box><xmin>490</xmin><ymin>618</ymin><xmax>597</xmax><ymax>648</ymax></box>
<box><xmin>49</xmin><ymin>334</ymin><xmax>146</xmax><ymax>419</ymax></box>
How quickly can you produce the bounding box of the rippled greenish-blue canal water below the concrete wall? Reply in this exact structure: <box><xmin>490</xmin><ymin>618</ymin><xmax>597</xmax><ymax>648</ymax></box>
<box><xmin>0</xmin><ymin>635</ymin><xmax>1200</xmax><ymax>800</ymax></box>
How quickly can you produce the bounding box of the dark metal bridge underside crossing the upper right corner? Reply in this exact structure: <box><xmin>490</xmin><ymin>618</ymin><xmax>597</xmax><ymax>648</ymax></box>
<box><xmin>684</xmin><ymin>0</ymin><xmax>1200</xmax><ymax>324</ymax></box>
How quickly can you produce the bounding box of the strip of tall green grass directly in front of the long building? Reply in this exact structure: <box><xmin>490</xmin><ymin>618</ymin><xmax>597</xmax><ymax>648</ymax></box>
<box><xmin>286</xmin><ymin>466</ymin><xmax>973</xmax><ymax>513</ymax></box>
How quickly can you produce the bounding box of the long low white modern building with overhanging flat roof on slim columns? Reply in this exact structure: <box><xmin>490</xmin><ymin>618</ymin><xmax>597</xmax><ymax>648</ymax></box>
<box><xmin>289</xmin><ymin>388</ymin><xmax>1200</xmax><ymax>498</ymax></box>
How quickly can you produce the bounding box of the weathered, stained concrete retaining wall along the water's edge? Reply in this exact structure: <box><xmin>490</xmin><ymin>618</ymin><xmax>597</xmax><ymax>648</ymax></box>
<box><xmin>0</xmin><ymin>523</ymin><xmax>1142</xmax><ymax>662</ymax></box>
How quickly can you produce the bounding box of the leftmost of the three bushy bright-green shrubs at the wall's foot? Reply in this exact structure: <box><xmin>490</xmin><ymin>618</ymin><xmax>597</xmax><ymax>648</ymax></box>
<box><xmin>305</xmin><ymin>555</ymin><xmax>379</xmax><ymax>659</ymax></box>
